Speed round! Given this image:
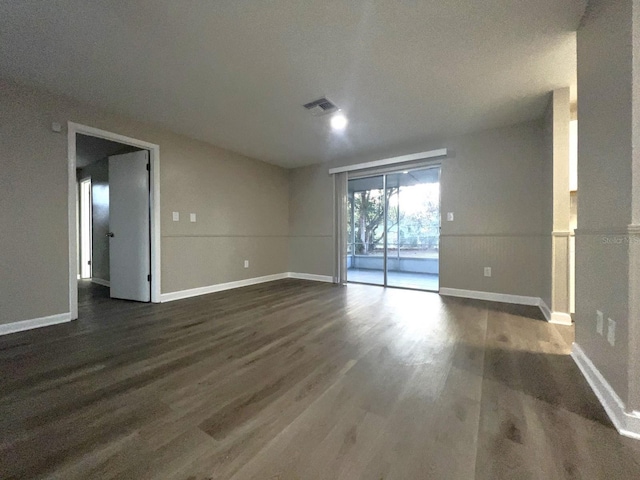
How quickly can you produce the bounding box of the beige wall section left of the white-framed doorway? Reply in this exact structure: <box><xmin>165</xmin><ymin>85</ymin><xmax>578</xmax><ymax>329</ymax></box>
<box><xmin>0</xmin><ymin>83</ymin><xmax>69</xmax><ymax>323</ymax></box>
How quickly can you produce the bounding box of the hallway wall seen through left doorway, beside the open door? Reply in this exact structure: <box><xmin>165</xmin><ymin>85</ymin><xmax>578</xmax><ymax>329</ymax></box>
<box><xmin>78</xmin><ymin>158</ymin><xmax>111</xmax><ymax>281</ymax></box>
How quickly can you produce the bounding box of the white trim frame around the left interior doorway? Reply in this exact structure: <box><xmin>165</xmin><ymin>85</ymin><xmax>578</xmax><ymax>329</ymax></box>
<box><xmin>67</xmin><ymin>122</ymin><xmax>161</xmax><ymax>320</ymax></box>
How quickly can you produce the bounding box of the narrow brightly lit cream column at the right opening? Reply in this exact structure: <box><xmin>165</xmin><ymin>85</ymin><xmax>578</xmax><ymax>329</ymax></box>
<box><xmin>551</xmin><ymin>87</ymin><xmax>571</xmax><ymax>325</ymax></box>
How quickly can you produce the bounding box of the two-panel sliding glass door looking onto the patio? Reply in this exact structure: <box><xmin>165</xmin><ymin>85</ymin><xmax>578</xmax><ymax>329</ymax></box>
<box><xmin>347</xmin><ymin>166</ymin><xmax>440</xmax><ymax>292</ymax></box>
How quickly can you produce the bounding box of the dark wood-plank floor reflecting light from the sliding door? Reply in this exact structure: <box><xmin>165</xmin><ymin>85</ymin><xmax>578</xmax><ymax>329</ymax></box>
<box><xmin>0</xmin><ymin>280</ymin><xmax>640</xmax><ymax>480</ymax></box>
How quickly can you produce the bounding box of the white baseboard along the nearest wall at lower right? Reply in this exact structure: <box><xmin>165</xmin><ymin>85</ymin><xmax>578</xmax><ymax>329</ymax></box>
<box><xmin>571</xmin><ymin>343</ymin><xmax>640</xmax><ymax>440</ymax></box>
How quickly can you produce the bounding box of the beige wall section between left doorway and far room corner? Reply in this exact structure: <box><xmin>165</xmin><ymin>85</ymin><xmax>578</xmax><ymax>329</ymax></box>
<box><xmin>160</xmin><ymin>138</ymin><xmax>289</xmax><ymax>292</ymax></box>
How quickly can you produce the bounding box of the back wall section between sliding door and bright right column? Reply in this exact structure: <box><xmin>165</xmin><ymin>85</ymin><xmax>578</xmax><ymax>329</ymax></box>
<box><xmin>440</xmin><ymin>122</ymin><xmax>551</xmax><ymax>297</ymax></box>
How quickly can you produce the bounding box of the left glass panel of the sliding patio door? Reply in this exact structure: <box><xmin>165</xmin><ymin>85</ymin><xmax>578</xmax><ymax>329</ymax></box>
<box><xmin>347</xmin><ymin>175</ymin><xmax>385</xmax><ymax>285</ymax></box>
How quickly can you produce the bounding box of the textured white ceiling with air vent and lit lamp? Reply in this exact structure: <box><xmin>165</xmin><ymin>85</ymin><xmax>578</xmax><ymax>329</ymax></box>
<box><xmin>0</xmin><ymin>0</ymin><xmax>585</xmax><ymax>167</ymax></box>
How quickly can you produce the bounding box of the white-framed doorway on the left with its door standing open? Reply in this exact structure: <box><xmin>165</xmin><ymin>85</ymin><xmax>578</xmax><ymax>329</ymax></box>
<box><xmin>68</xmin><ymin>123</ymin><xmax>160</xmax><ymax>319</ymax></box>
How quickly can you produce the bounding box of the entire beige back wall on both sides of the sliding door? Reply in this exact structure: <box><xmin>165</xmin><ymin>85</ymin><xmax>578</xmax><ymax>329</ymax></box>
<box><xmin>290</xmin><ymin>122</ymin><xmax>551</xmax><ymax>297</ymax></box>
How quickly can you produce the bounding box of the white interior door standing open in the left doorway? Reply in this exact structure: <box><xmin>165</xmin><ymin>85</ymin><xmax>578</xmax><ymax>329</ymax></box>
<box><xmin>108</xmin><ymin>150</ymin><xmax>151</xmax><ymax>302</ymax></box>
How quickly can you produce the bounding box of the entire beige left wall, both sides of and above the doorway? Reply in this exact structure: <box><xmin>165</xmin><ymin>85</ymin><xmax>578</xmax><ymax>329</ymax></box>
<box><xmin>0</xmin><ymin>82</ymin><xmax>289</xmax><ymax>323</ymax></box>
